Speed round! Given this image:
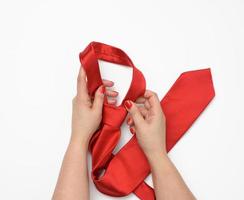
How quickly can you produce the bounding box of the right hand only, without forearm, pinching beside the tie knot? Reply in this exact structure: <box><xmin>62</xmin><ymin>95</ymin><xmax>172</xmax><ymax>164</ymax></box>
<box><xmin>124</xmin><ymin>90</ymin><xmax>167</xmax><ymax>158</ymax></box>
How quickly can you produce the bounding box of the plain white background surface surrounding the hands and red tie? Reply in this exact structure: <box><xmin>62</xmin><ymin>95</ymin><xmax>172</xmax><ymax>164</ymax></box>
<box><xmin>0</xmin><ymin>0</ymin><xmax>244</xmax><ymax>200</ymax></box>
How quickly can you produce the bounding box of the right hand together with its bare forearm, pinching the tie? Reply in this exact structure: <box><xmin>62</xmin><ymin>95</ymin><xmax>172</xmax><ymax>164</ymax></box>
<box><xmin>125</xmin><ymin>90</ymin><xmax>196</xmax><ymax>200</ymax></box>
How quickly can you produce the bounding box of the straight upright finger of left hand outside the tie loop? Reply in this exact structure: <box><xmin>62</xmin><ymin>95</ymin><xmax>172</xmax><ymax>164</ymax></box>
<box><xmin>77</xmin><ymin>66</ymin><xmax>90</xmax><ymax>101</ymax></box>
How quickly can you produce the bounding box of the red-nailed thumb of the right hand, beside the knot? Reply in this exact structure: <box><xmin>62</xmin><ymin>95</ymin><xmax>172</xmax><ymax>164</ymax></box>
<box><xmin>124</xmin><ymin>100</ymin><xmax>144</xmax><ymax>125</ymax></box>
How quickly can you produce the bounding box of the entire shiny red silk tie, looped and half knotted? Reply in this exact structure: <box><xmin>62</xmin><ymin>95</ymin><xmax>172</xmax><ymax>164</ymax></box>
<box><xmin>80</xmin><ymin>42</ymin><xmax>215</xmax><ymax>200</ymax></box>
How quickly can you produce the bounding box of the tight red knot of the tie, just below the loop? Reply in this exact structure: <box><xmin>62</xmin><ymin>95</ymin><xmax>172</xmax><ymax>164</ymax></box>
<box><xmin>103</xmin><ymin>104</ymin><xmax>127</xmax><ymax>128</ymax></box>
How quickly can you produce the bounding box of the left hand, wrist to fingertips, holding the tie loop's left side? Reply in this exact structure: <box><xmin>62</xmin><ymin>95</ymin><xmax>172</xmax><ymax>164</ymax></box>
<box><xmin>71</xmin><ymin>66</ymin><xmax>118</xmax><ymax>146</ymax></box>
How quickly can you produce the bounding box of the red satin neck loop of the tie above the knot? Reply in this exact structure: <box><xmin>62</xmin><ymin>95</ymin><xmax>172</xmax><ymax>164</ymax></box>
<box><xmin>79</xmin><ymin>42</ymin><xmax>146</xmax><ymax>104</ymax></box>
